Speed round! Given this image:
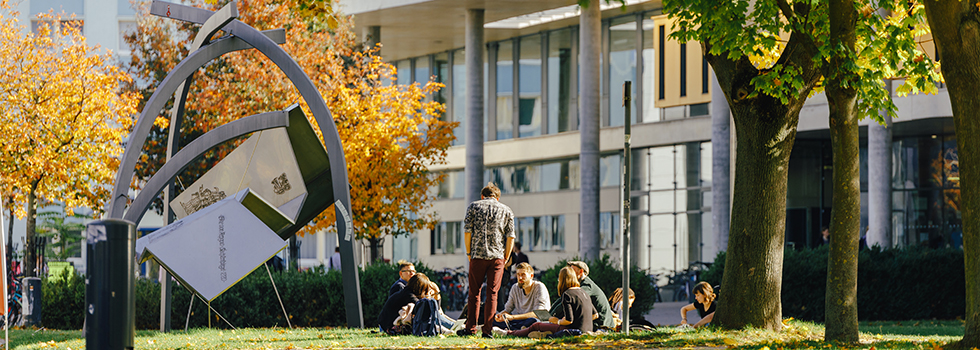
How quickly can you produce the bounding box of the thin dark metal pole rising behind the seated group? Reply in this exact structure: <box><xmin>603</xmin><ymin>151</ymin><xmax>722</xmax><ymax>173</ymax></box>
<box><xmin>620</xmin><ymin>81</ymin><xmax>633</xmax><ymax>334</ymax></box>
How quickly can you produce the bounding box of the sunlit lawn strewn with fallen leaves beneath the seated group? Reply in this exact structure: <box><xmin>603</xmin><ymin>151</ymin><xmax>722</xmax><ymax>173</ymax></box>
<box><xmin>0</xmin><ymin>320</ymin><xmax>963</xmax><ymax>350</ymax></box>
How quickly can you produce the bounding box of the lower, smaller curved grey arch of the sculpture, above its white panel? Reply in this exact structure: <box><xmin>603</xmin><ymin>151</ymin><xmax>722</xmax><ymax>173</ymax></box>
<box><xmin>123</xmin><ymin>109</ymin><xmax>290</xmax><ymax>222</ymax></box>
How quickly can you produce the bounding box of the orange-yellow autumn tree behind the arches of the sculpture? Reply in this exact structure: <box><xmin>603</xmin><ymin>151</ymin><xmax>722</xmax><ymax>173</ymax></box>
<box><xmin>123</xmin><ymin>0</ymin><xmax>454</xmax><ymax>259</ymax></box>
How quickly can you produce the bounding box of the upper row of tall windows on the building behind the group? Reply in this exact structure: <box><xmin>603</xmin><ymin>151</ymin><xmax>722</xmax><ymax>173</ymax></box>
<box><xmin>395</xmin><ymin>12</ymin><xmax>709</xmax><ymax>145</ymax></box>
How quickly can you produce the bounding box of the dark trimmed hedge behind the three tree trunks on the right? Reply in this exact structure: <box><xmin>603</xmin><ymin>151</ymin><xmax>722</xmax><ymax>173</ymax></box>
<box><xmin>701</xmin><ymin>246</ymin><xmax>966</xmax><ymax>322</ymax></box>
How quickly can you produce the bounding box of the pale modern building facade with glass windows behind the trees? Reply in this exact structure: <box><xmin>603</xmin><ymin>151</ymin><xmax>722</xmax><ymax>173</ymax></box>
<box><xmin>341</xmin><ymin>0</ymin><xmax>962</xmax><ymax>273</ymax></box>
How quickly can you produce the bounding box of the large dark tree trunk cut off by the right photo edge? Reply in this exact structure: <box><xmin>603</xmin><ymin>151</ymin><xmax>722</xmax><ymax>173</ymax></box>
<box><xmin>925</xmin><ymin>0</ymin><xmax>980</xmax><ymax>348</ymax></box>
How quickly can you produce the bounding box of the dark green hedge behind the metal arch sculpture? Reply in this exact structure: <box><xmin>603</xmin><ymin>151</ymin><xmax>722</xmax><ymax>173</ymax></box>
<box><xmin>41</xmin><ymin>263</ymin><xmax>432</xmax><ymax>329</ymax></box>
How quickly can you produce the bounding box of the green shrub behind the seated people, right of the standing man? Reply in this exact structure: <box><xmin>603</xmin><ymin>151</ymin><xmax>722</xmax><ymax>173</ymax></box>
<box><xmin>541</xmin><ymin>254</ymin><xmax>656</xmax><ymax>315</ymax></box>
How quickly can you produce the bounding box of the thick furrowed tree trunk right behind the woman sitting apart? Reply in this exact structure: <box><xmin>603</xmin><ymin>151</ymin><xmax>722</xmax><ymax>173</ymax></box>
<box><xmin>714</xmin><ymin>95</ymin><xmax>802</xmax><ymax>331</ymax></box>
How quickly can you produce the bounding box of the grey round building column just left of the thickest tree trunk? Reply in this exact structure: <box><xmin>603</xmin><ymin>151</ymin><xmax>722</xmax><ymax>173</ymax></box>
<box><xmin>706</xmin><ymin>71</ymin><xmax>732</xmax><ymax>252</ymax></box>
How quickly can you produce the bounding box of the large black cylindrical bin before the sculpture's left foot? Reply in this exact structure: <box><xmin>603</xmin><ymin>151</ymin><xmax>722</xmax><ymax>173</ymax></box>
<box><xmin>85</xmin><ymin>219</ymin><xmax>136</xmax><ymax>350</ymax></box>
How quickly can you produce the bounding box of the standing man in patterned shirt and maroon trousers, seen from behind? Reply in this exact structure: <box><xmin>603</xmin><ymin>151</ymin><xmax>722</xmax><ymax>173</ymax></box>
<box><xmin>464</xmin><ymin>183</ymin><xmax>515</xmax><ymax>338</ymax></box>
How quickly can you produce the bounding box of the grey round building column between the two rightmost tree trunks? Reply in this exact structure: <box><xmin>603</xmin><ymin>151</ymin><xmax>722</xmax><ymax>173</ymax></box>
<box><xmin>867</xmin><ymin>81</ymin><xmax>893</xmax><ymax>248</ymax></box>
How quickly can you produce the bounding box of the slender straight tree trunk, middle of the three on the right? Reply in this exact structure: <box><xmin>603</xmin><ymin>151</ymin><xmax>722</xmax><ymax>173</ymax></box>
<box><xmin>824</xmin><ymin>0</ymin><xmax>861</xmax><ymax>343</ymax></box>
